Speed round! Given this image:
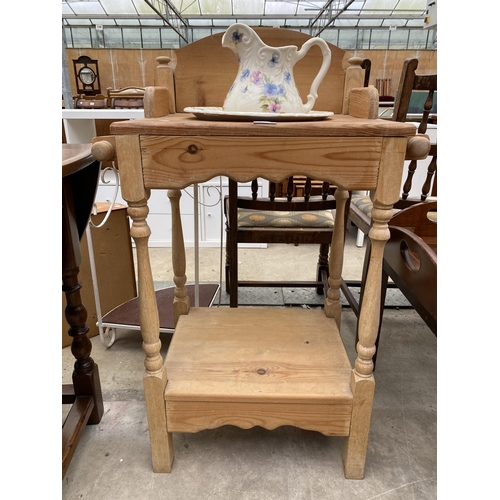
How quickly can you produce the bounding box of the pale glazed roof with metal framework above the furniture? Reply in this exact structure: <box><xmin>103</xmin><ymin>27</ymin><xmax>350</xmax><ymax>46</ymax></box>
<box><xmin>62</xmin><ymin>0</ymin><xmax>429</xmax><ymax>33</ymax></box>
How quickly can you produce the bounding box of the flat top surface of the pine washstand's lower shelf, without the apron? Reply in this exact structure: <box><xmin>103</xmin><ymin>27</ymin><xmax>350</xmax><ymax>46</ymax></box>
<box><xmin>165</xmin><ymin>308</ymin><xmax>352</xmax><ymax>404</ymax></box>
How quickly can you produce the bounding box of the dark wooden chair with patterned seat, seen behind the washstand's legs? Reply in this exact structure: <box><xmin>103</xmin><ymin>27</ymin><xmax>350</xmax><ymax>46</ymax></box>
<box><xmin>224</xmin><ymin>59</ymin><xmax>371</xmax><ymax>307</ymax></box>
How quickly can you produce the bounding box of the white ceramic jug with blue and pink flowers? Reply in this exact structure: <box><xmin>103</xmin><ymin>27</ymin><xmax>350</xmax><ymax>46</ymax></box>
<box><xmin>222</xmin><ymin>23</ymin><xmax>331</xmax><ymax>113</ymax></box>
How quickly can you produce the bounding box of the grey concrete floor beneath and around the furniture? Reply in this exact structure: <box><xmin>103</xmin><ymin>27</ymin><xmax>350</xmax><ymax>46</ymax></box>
<box><xmin>62</xmin><ymin>228</ymin><xmax>437</xmax><ymax>500</ymax></box>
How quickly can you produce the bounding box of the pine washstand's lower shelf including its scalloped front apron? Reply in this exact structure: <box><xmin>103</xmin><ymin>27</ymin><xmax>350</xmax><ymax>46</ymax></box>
<box><xmin>165</xmin><ymin>307</ymin><xmax>353</xmax><ymax>436</ymax></box>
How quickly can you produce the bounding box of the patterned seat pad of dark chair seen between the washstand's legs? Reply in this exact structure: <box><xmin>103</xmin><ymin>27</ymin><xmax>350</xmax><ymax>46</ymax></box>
<box><xmin>238</xmin><ymin>208</ymin><xmax>334</xmax><ymax>228</ymax></box>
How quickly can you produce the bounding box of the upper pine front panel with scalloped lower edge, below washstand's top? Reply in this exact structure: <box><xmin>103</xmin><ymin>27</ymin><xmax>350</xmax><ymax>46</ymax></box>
<box><xmin>141</xmin><ymin>136</ymin><xmax>382</xmax><ymax>190</ymax></box>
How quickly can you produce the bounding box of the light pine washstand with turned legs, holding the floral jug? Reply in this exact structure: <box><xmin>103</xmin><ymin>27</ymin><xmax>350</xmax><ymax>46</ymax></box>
<box><xmin>92</xmin><ymin>29</ymin><xmax>428</xmax><ymax>478</ymax></box>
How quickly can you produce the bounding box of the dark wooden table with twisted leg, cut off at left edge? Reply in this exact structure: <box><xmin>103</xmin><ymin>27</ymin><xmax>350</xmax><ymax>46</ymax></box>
<box><xmin>62</xmin><ymin>144</ymin><xmax>104</xmax><ymax>478</ymax></box>
